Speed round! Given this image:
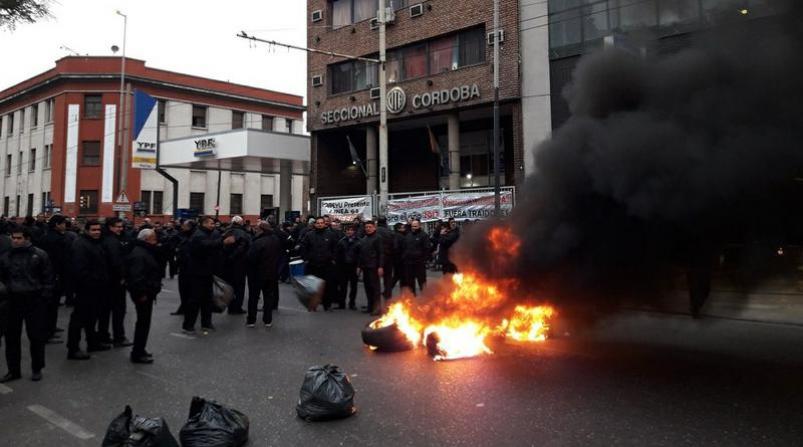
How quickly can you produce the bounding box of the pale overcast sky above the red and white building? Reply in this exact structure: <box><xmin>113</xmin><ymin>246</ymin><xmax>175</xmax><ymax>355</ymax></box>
<box><xmin>0</xmin><ymin>0</ymin><xmax>307</xmax><ymax>104</ymax></box>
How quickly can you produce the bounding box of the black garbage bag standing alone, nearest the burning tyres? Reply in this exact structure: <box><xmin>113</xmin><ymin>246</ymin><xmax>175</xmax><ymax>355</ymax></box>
<box><xmin>296</xmin><ymin>365</ymin><xmax>357</xmax><ymax>421</ymax></box>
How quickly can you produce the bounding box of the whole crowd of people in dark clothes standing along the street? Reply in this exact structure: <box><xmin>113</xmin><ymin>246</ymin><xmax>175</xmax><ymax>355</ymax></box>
<box><xmin>0</xmin><ymin>215</ymin><xmax>460</xmax><ymax>383</ymax></box>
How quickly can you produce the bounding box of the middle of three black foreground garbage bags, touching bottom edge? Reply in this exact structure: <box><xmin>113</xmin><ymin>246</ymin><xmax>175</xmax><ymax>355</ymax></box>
<box><xmin>178</xmin><ymin>397</ymin><xmax>250</xmax><ymax>447</ymax></box>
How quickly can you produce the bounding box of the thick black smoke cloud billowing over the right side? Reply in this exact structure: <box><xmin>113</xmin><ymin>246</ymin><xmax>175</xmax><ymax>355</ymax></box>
<box><xmin>457</xmin><ymin>8</ymin><xmax>803</xmax><ymax>310</ymax></box>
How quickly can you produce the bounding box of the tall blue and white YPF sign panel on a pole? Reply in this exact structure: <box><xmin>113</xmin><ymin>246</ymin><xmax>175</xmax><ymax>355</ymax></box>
<box><xmin>131</xmin><ymin>90</ymin><xmax>159</xmax><ymax>169</ymax></box>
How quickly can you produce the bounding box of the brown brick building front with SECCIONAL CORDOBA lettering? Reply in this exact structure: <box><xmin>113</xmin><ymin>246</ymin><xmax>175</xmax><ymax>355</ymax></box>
<box><xmin>307</xmin><ymin>0</ymin><xmax>549</xmax><ymax>201</ymax></box>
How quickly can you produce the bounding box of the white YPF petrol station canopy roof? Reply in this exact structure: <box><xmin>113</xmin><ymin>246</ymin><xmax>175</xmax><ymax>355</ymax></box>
<box><xmin>159</xmin><ymin>129</ymin><xmax>310</xmax><ymax>175</ymax></box>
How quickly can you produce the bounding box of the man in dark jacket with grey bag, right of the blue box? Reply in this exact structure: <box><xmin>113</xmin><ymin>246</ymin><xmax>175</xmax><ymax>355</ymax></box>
<box><xmin>301</xmin><ymin>217</ymin><xmax>337</xmax><ymax>310</ymax></box>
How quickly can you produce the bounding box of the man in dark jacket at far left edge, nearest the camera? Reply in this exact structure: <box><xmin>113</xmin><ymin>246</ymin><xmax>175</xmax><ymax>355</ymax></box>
<box><xmin>0</xmin><ymin>228</ymin><xmax>53</xmax><ymax>383</ymax></box>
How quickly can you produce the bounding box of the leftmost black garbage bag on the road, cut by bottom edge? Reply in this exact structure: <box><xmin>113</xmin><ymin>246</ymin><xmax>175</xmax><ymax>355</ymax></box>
<box><xmin>102</xmin><ymin>405</ymin><xmax>179</xmax><ymax>447</ymax></box>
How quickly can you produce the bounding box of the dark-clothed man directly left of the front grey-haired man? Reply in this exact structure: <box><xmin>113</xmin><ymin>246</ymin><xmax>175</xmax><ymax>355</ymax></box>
<box><xmin>98</xmin><ymin>217</ymin><xmax>131</xmax><ymax>348</ymax></box>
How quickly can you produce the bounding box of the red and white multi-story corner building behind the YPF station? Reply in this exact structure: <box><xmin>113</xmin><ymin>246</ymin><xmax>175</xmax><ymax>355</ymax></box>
<box><xmin>0</xmin><ymin>56</ymin><xmax>307</xmax><ymax>221</ymax></box>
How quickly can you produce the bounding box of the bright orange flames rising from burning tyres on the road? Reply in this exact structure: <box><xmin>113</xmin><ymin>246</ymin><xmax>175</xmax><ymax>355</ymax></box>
<box><xmin>370</xmin><ymin>227</ymin><xmax>556</xmax><ymax>360</ymax></box>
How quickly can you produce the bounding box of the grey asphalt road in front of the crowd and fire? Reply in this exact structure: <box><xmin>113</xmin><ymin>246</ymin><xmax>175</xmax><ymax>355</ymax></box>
<box><xmin>0</xmin><ymin>274</ymin><xmax>803</xmax><ymax>447</ymax></box>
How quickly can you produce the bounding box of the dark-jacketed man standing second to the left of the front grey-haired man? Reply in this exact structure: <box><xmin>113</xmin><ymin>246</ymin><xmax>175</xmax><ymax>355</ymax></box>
<box><xmin>67</xmin><ymin>220</ymin><xmax>111</xmax><ymax>360</ymax></box>
